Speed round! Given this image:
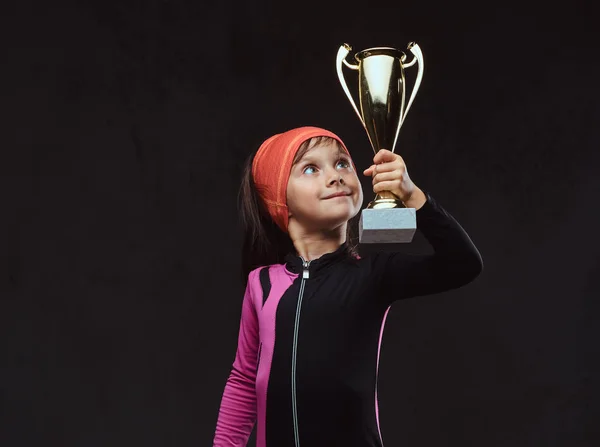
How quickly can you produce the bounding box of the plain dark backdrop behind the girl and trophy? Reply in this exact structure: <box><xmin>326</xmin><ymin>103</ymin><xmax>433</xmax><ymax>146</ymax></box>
<box><xmin>0</xmin><ymin>0</ymin><xmax>600</xmax><ymax>447</ymax></box>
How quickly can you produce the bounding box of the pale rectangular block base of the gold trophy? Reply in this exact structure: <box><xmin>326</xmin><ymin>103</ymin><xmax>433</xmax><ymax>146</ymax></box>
<box><xmin>358</xmin><ymin>208</ymin><xmax>417</xmax><ymax>244</ymax></box>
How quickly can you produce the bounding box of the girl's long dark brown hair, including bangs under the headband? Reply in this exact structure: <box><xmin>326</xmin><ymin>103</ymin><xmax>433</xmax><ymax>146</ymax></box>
<box><xmin>238</xmin><ymin>137</ymin><xmax>358</xmax><ymax>283</ymax></box>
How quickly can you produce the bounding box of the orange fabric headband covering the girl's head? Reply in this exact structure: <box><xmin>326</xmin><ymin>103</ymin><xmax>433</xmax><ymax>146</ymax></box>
<box><xmin>252</xmin><ymin>126</ymin><xmax>350</xmax><ymax>233</ymax></box>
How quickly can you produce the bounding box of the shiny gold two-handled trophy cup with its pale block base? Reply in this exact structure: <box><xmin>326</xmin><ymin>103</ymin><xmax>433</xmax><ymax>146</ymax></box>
<box><xmin>336</xmin><ymin>42</ymin><xmax>423</xmax><ymax>243</ymax></box>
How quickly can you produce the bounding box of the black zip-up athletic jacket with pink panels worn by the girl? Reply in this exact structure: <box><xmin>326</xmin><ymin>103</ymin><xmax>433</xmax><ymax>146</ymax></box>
<box><xmin>213</xmin><ymin>193</ymin><xmax>483</xmax><ymax>447</ymax></box>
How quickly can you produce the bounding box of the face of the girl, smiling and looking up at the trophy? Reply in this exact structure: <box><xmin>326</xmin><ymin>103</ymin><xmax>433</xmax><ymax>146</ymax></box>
<box><xmin>287</xmin><ymin>142</ymin><xmax>363</xmax><ymax>231</ymax></box>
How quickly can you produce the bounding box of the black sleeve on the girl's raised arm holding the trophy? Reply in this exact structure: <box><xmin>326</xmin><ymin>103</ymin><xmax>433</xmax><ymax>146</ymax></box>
<box><xmin>377</xmin><ymin>192</ymin><xmax>483</xmax><ymax>304</ymax></box>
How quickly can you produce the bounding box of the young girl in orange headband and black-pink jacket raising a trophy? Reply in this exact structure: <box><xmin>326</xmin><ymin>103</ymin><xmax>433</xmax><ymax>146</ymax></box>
<box><xmin>213</xmin><ymin>127</ymin><xmax>483</xmax><ymax>447</ymax></box>
